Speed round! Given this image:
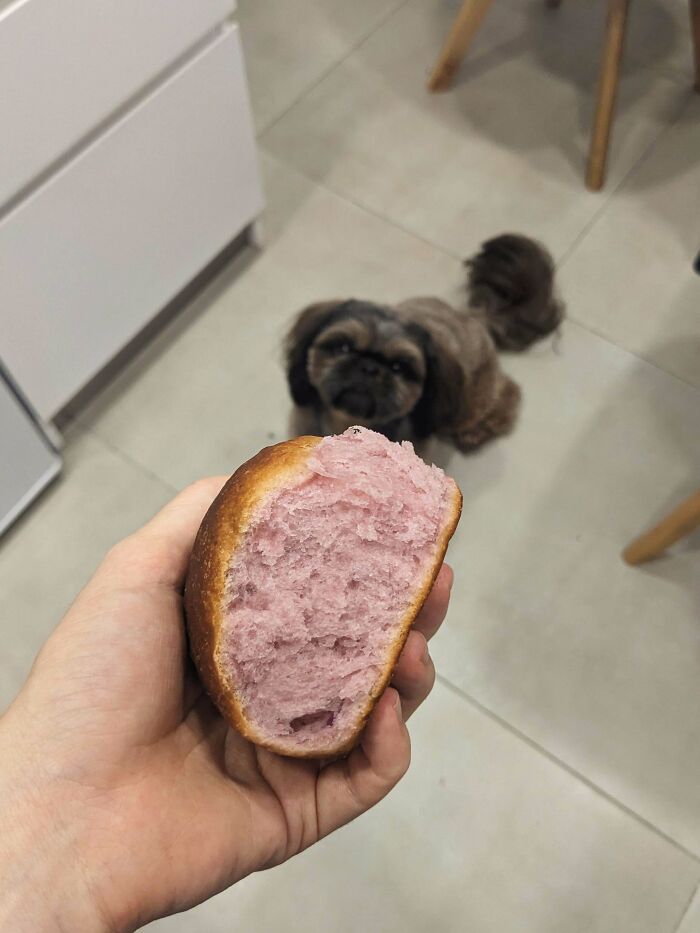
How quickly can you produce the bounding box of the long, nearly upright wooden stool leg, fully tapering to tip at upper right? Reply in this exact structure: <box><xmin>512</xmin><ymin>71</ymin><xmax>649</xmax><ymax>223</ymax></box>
<box><xmin>586</xmin><ymin>0</ymin><xmax>629</xmax><ymax>191</ymax></box>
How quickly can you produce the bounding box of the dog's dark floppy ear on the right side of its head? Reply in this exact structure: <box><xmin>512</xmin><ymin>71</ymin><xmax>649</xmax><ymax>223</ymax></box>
<box><xmin>410</xmin><ymin>325</ymin><xmax>467</xmax><ymax>437</ymax></box>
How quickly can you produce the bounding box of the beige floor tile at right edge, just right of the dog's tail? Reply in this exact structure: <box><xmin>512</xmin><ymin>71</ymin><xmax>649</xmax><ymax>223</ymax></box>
<box><xmin>560</xmin><ymin>98</ymin><xmax>700</xmax><ymax>386</ymax></box>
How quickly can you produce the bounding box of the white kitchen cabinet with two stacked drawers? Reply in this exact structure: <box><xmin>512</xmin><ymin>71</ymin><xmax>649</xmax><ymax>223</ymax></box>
<box><xmin>0</xmin><ymin>0</ymin><xmax>263</xmax><ymax>532</ymax></box>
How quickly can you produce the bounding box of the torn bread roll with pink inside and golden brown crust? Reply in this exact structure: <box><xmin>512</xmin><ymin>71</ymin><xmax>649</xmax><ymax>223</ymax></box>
<box><xmin>185</xmin><ymin>428</ymin><xmax>462</xmax><ymax>758</ymax></box>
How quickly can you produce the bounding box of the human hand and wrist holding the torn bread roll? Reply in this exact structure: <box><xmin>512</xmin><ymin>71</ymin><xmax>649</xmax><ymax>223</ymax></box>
<box><xmin>0</xmin><ymin>477</ymin><xmax>452</xmax><ymax>933</ymax></box>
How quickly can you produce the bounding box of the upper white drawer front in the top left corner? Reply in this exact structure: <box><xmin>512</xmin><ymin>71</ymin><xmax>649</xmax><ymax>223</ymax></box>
<box><xmin>0</xmin><ymin>0</ymin><xmax>235</xmax><ymax>206</ymax></box>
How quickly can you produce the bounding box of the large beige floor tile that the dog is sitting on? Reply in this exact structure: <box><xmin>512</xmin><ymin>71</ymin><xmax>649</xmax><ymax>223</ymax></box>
<box><xmin>74</xmin><ymin>151</ymin><xmax>700</xmax><ymax>853</ymax></box>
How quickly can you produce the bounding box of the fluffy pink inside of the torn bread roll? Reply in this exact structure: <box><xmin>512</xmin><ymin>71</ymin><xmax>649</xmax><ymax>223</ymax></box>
<box><xmin>220</xmin><ymin>428</ymin><xmax>454</xmax><ymax>748</ymax></box>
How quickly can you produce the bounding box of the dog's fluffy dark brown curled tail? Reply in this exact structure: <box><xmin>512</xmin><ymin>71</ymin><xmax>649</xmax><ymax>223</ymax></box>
<box><xmin>464</xmin><ymin>233</ymin><xmax>564</xmax><ymax>350</ymax></box>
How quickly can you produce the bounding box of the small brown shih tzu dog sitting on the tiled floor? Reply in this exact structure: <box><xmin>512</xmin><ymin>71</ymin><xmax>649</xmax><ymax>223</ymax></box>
<box><xmin>285</xmin><ymin>234</ymin><xmax>564</xmax><ymax>451</ymax></box>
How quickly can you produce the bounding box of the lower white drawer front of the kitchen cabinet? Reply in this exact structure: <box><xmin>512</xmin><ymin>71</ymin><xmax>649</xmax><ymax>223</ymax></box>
<box><xmin>0</xmin><ymin>26</ymin><xmax>262</xmax><ymax>420</ymax></box>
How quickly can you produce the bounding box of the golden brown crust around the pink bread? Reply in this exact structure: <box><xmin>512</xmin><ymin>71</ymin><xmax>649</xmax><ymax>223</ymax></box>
<box><xmin>185</xmin><ymin>437</ymin><xmax>462</xmax><ymax>758</ymax></box>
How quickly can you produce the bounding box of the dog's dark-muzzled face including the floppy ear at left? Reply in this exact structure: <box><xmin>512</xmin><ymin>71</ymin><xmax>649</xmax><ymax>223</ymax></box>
<box><xmin>287</xmin><ymin>301</ymin><xmax>427</xmax><ymax>427</ymax></box>
